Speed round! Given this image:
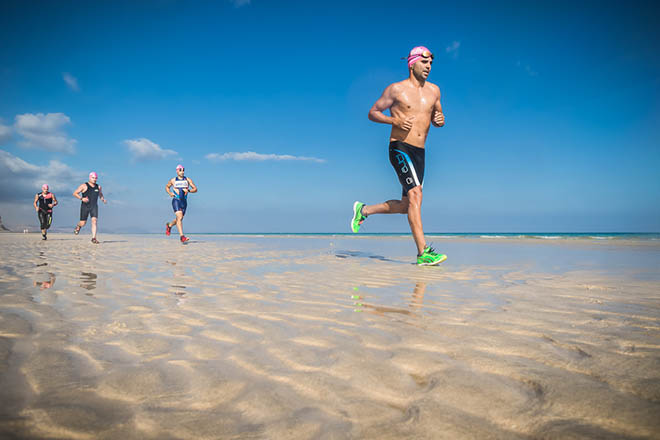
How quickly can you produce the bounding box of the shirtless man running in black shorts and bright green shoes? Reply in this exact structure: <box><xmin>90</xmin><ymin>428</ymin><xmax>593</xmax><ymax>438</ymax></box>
<box><xmin>351</xmin><ymin>46</ymin><xmax>447</xmax><ymax>266</ymax></box>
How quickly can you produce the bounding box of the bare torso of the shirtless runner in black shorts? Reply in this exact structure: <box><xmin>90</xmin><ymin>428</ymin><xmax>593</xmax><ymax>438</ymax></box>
<box><xmin>390</xmin><ymin>79</ymin><xmax>440</xmax><ymax>148</ymax></box>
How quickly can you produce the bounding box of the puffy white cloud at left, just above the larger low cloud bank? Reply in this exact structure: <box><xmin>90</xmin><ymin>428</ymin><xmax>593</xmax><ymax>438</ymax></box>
<box><xmin>14</xmin><ymin>113</ymin><xmax>77</xmax><ymax>154</ymax></box>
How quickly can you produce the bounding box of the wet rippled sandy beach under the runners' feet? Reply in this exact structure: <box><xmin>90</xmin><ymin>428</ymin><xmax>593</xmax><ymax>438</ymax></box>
<box><xmin>0</xmin><ymin>231</ymin><xmax>660</xmax><ymax>439</ymax></box>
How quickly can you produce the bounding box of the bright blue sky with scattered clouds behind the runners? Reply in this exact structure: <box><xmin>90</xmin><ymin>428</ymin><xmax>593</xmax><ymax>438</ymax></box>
<box><xmin>0</xmin><ymin>0</ymin><xmax>660</xmax><ymax>232</ymax></box>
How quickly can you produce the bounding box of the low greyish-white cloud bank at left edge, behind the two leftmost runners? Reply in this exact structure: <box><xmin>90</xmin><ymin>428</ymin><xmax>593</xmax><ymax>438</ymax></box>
<box><xmin>0</xmin><ymin>150</ymin><xmax>86</xmax><ymax>202</ymax></box>
